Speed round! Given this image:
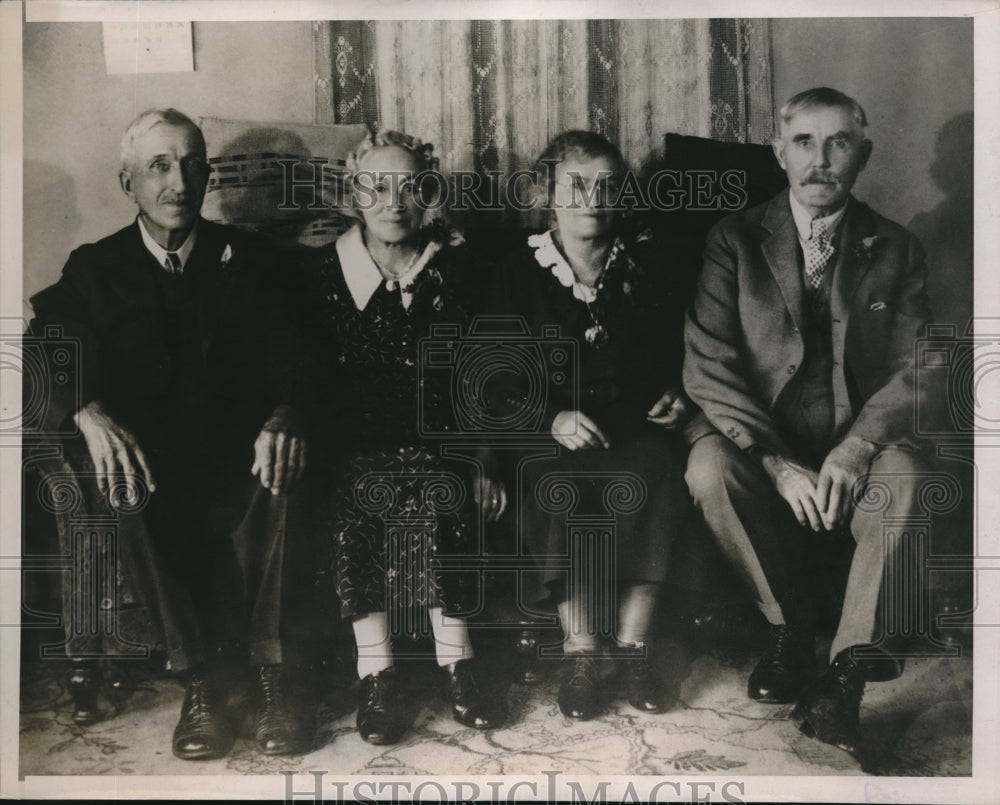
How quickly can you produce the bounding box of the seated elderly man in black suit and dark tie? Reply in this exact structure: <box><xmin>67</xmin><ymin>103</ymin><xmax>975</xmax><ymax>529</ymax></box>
<box><xmin>30</xmin><ymin>109</ymin><xmax>308</xmax><ymax>759</ymax></box>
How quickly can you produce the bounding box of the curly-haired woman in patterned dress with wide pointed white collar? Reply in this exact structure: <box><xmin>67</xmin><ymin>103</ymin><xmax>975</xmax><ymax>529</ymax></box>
<box><xmin>308</xmin><ymin>131</ymin><xmax>505</xmax><ymax>743</ymax></box>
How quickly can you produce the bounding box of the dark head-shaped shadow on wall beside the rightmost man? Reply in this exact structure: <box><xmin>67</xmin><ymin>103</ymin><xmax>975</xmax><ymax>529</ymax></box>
<box><xmin>908</xmin><ymin>112</ymin><xmax>974</xmax><ymax>335</ymax></box>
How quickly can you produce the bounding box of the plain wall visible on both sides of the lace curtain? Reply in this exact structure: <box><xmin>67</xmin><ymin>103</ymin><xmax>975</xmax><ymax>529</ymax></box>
<box><xmin>24</xmin><ymin>18</ymin><xmax>973</xmax><ymax>330</ymax></box>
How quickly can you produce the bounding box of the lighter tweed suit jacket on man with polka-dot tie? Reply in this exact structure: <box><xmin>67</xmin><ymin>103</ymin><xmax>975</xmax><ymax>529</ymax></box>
<box><xmin>684</xmin><ymin>191</ymin><xmax>930</xmax><ymax>455</ymax></box>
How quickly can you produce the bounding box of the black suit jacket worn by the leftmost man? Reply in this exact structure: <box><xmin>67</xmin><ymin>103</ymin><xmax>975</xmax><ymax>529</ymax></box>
<box><xmin>29</xmin><ymin>220</ymin><xmax>309</xmax><ymax>462</ymax></box>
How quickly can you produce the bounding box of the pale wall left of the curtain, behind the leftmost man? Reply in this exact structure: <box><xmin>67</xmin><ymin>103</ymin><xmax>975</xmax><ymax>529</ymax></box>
<box><xmin>24</xmin><ymin>21</ymin><xmax>313</xmax><ymax>314</ymax></box>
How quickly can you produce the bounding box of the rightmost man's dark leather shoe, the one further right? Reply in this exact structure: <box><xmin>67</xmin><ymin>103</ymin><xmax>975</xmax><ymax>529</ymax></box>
<box><xmin>792</xmin><ymin>649</ymin><xmax>865</xmax><ymax>755</ymax></box>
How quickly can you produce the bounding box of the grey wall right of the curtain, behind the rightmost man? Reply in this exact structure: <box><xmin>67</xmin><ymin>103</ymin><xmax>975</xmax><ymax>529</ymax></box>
<box><xmin>771</xmin><ymin>18</ymin><xmax>973</xmax><ymax>327</ymax></box>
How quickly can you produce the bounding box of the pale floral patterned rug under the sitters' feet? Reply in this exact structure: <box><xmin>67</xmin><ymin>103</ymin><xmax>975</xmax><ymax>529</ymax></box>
<box><xmin>20</xmin><ymin>646</ymin><xmax>972</xmax><ymax>777</ymax></box>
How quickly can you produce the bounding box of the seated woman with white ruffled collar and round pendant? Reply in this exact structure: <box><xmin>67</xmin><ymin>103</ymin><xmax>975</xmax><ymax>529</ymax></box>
<box><xmin>489</xmin><ymin>131</ymin><xmax>690</xmax><ymax>719</ymax></box>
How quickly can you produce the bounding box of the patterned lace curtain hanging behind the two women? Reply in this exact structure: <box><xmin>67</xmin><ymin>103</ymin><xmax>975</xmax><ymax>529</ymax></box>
<box><xmin>314</xmin><ymin>19</ymin><xmax>773</xmax><ymax>217</ymax></box>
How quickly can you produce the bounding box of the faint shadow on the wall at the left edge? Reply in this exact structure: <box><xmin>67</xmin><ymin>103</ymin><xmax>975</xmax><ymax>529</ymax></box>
<box><xmin>24</xmin><ymin>159</ymin><xmax>83</xmax><ymax>315</ymax></box>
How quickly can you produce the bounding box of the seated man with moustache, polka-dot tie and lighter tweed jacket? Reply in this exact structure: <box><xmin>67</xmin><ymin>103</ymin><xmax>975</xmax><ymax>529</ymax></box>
<box><xmin>684</xmin><ymin>87</ymin><xmax>929</xmax><ymax>752</ymax></box>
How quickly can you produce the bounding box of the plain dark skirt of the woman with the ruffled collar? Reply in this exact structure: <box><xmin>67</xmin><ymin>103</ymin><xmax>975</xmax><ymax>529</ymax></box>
<box><xmin>519</xmin><ymin>425</ymin><xmax>691</xmax><ymax>606</ymax></box>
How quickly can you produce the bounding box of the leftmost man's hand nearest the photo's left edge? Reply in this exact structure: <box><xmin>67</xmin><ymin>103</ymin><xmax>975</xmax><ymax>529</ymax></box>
<box><xmin>73</xmin><ymin>400</ymin><xmax>156</xmax><ymax>500</ymax></box>
